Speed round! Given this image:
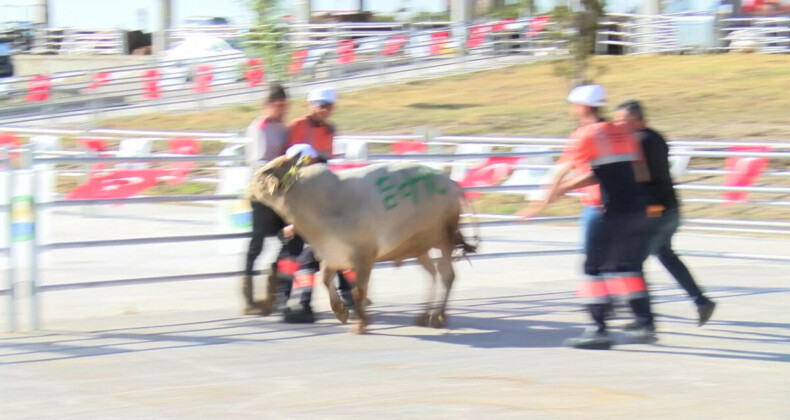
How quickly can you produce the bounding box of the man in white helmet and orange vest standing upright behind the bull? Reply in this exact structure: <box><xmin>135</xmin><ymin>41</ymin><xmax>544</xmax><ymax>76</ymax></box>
<box><xmin>288</xmin><ymin>88</ymin><xmax>354</xmax><ymax>307</ymax></box>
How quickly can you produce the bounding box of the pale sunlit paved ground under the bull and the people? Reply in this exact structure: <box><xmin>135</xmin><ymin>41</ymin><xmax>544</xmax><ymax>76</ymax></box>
<box><xmin>0</xmin><ymin>206</ymin><xmax>790</xmax><ymax>420</ymax></box>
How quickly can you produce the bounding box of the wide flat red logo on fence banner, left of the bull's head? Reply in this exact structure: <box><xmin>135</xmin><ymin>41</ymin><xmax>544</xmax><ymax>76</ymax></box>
<box><xmin>66</xmin><ymin>169</ymin><xmax>163</xmax><ymax>200</ymax></box>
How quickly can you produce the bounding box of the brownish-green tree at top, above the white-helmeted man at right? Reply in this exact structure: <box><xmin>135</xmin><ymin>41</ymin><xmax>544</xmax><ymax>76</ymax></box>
<box><xmin>550</xmin><ymin>0</ymin><xmax>606</xmax><ymax>87</ymax></box>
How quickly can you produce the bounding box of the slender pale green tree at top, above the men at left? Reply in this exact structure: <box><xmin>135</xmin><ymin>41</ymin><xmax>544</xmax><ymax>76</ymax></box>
<box><xmin>244</xmin><ymin>0</ymin><xmax>290</xmax><ymax>80</ymax></box>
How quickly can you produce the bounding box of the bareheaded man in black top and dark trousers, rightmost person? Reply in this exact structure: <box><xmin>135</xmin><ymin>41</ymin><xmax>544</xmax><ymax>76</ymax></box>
<box><xmin>615</xmin><ymin>100</ymin><xmax>716</xmax><ymax>326</ymax></box>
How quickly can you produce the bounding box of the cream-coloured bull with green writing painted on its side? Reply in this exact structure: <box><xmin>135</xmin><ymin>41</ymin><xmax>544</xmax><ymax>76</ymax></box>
<box><xmin>250</xmin><ymin>156</ymin><xmax>477</xmax><ymax>333</ymax></box>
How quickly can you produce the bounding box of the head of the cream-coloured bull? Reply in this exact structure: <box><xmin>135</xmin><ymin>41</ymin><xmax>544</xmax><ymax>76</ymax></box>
<box><xmin>250</xmin><ymin>156</ymin><xmax>310</xmax><ymax>207</ymax></box>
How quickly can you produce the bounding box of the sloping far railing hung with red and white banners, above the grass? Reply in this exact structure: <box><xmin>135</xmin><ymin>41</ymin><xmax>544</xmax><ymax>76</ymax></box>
<box><xmin>0</xmin><ymin>17</ymin><xmax>565</xmax><ymax>123</ymax></box>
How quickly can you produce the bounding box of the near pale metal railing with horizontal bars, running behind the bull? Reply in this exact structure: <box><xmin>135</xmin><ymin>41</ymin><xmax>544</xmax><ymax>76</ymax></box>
<box><xmin>0</xmin><ymin>129</ymin><xmax>790</xmax><ymax>329</ymax></box>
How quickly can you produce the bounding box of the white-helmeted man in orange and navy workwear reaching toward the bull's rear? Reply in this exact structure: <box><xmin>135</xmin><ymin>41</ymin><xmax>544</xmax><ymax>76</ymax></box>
<box><xmin>522</xmin><ymin>85</ymin><xmax>655</xmax><ymax>349</ymax></box>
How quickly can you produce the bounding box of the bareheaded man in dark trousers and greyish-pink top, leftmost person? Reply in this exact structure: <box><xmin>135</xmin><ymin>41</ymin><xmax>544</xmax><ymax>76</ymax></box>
<box><xmin>242</xmin><ymin>84</ymin><xmax>288</xmax><ymax>315</ymax></box>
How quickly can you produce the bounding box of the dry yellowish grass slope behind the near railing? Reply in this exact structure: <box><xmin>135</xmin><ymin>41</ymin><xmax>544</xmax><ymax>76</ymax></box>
<box><xmin>94</xmin><ymin>54</ymin><xmax>790</xmax><ymax>220</ymax></box>
